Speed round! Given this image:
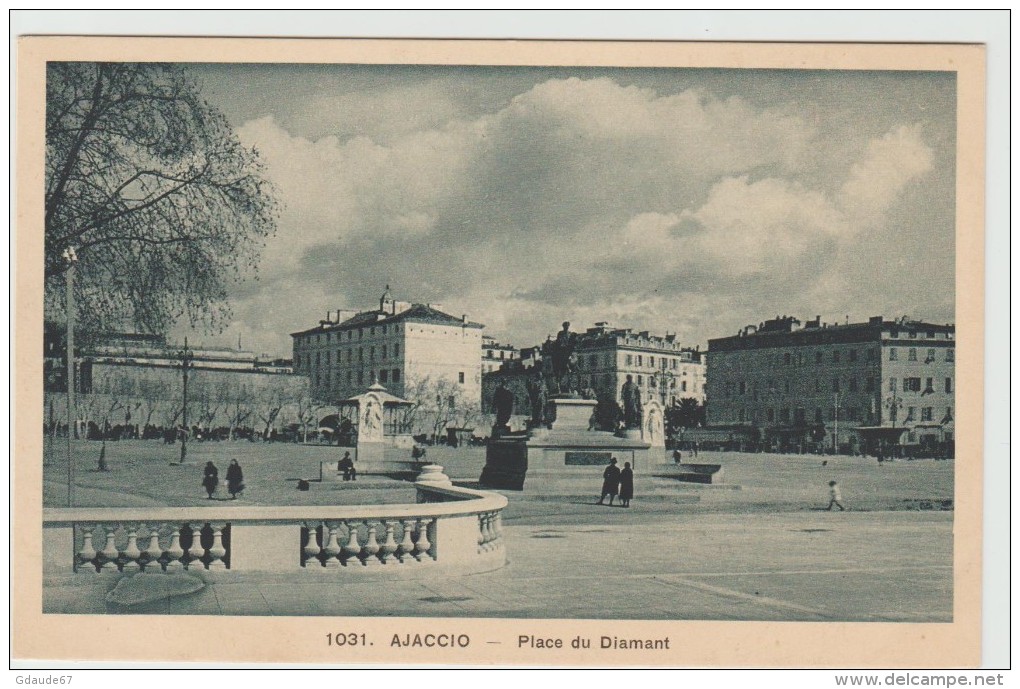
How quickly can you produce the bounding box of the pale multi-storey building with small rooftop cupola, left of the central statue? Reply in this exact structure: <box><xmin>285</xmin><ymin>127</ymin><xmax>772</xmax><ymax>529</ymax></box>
<box><xmin>291</xmin><ymin>288</ymin><xmax>485</xmax><ymax>409</ymax></box>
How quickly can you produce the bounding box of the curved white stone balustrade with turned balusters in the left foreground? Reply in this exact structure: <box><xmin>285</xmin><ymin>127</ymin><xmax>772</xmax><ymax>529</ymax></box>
<box><xmin>43</xmin><ymin>482</ymin><xmax>507</xmax><ymax>576</ymax></box>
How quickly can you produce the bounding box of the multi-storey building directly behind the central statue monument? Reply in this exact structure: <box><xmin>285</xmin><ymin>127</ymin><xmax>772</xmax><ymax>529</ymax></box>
<box><xmin>483</xmin><ymin>323</ymin><xmax>706</xmax><ymax>410</ymax></box>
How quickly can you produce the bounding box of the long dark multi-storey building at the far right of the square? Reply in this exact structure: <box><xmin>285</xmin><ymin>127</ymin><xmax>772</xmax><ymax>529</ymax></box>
<box><xmin>708</xmin><ymin>316</ymin><xmax>956</xmax><ymax>452</ymax></box>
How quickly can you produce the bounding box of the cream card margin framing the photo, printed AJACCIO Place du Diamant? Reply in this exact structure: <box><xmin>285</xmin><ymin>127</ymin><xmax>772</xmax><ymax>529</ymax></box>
<box><xmin>11</xmin><ymin>37</ymin><xmax>985</xmax><ymax>668</ymax></box>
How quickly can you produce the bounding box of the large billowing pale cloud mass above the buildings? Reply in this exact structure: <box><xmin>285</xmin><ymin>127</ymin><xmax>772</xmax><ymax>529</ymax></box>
<box><xmin>217</xmin><ymin>78</ymin><xmax>936</xmax><ymax>353</ymax></box>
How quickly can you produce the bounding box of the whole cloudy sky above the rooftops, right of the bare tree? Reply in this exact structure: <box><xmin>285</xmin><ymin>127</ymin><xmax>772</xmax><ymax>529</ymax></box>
<box><xmin>181</xmin><ymin>64</ymin><xmax>956</xmax><ymax>356</ymax></box>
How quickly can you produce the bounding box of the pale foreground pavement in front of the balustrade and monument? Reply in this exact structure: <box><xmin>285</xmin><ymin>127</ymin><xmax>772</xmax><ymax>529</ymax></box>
<box><xmin>44</xmin><ymin>504</ymin><xmax>953</xmax><ymax>622</ymax></box>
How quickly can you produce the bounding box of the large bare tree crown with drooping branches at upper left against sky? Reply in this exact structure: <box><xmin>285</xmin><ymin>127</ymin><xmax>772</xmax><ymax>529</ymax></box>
<box><xmin>45</xmin><ymin>61</ymin><xmax>276</xmax><ymax>334</ymax></box>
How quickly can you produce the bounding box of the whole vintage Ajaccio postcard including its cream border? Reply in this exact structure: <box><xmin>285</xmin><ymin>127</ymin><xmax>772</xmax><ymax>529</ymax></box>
<box><xmin>12</xmin><ymin>37</ymin><xmax>985</xmax><ymax>668</ymax></box>
